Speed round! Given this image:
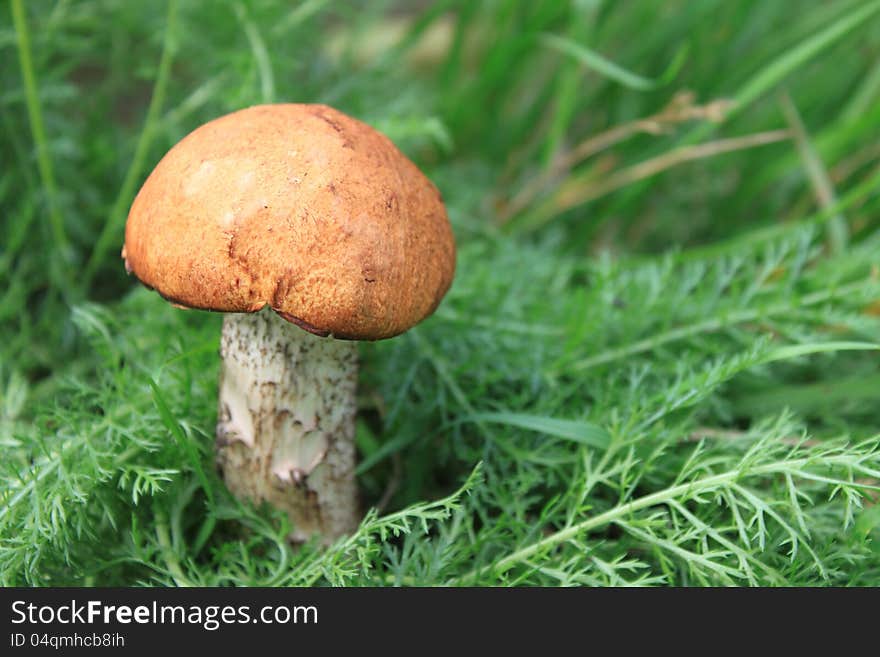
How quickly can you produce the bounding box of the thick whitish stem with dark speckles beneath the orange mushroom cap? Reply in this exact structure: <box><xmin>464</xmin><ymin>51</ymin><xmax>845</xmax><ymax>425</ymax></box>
<box><xmin>217</xmin><ymin>308</ymin><xmax>360</xmax><ymax>544</ymax></box>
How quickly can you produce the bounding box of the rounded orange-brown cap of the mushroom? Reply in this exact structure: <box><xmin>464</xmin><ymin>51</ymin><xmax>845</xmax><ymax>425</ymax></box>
<box><xmin>122</xmin><ymin>104</ymin><xmax>455</xmax><ymax>340</ymax></box>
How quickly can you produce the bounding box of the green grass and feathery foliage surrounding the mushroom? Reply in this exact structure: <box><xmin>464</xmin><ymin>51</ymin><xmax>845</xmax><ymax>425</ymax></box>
<box><xmin>0</xmin><ymin>0</ymin><xmax>880</xmax><ymax>586</ymax></box>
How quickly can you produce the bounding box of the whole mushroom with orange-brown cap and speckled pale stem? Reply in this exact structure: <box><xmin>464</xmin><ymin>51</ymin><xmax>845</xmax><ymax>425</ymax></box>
<box><xmin>122</xmin><ymin>104</ymin><xmax>455</xmax><ymax>544</ymax></box>
